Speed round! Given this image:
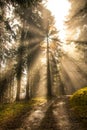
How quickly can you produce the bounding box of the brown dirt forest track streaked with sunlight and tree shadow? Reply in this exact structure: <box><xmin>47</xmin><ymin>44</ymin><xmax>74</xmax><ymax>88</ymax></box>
<box><xmin>0</xmin><ymin>96</ymin><xmax>87</xmax><ymax>130</ymax></box>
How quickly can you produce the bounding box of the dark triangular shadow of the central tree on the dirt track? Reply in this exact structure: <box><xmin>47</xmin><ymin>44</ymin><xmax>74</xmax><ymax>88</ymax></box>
<box><xmin>36</xmin><ymin>104</ymin><xmax>60</xmax><ymax>130</ymax></box>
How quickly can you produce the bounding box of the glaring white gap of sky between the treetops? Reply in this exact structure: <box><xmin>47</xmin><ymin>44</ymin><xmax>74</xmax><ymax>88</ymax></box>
<box><xmin>47</xmin><ymin>0</ymin><xmax>71</xmax><ymax>40</ymax></box>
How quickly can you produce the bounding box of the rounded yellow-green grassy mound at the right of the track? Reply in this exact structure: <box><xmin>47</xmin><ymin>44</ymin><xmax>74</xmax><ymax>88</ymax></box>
<box><xmin>70</xmin><ymin>87</ymin><xmax>87</xmax><ymax>120</ymax></box>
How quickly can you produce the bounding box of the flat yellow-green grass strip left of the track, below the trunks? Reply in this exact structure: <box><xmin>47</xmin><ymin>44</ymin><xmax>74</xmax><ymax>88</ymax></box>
<box><xmin>0</xmin><ymin>98</ymin><xmax>46</xmax><ymax>125</ymax></box>
